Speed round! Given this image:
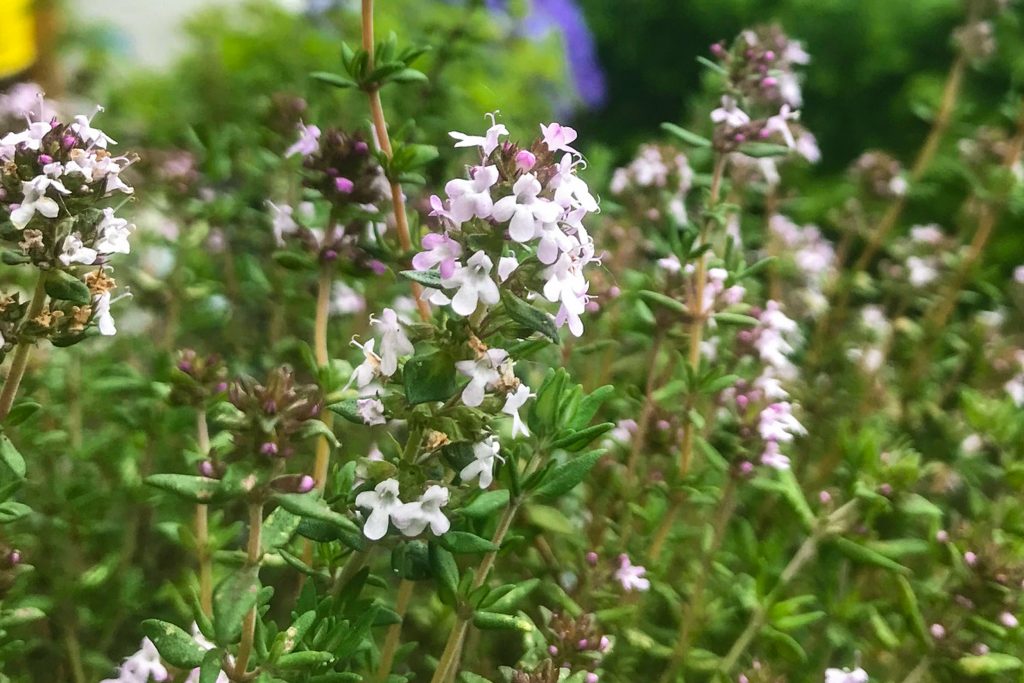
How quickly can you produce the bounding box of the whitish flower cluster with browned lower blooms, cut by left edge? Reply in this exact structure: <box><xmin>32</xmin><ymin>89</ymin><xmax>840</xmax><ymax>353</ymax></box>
<box><xmin>0</xmin><ymin>103</ymin><xmax>134</xmax><ymax>344</ymax></box>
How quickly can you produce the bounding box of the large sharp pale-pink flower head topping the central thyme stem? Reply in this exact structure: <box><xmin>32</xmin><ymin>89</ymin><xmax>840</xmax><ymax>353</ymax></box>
<box><xmin>413</xmin><ymin>117</ymin><xmax>598</xmax><ymax>336</ymax></box>
